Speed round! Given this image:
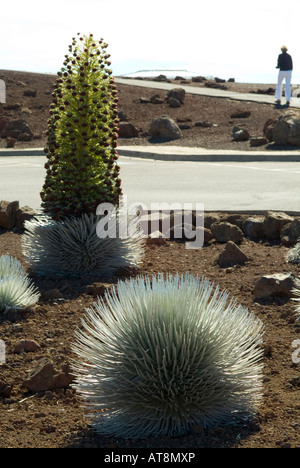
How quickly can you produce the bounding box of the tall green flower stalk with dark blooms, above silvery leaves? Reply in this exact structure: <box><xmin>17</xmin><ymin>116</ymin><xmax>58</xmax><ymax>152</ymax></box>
<box><xmin>41</xmin><ymin>34</ymin><xmax>122</xmax><ymax>220</ymax></box>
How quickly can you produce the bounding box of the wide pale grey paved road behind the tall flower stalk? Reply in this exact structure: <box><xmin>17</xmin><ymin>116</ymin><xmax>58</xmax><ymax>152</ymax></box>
<box><xmin>0</xmin><ymin>156</ymin><xmax>300</xmax><ymax>212</ymax></box>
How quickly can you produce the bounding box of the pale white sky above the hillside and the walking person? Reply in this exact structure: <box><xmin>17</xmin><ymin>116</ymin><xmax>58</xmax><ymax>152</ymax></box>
<box><xmin>0</xmin><ymin>0</ymin><xmax>300</xmax><ymax>84</ymax></box>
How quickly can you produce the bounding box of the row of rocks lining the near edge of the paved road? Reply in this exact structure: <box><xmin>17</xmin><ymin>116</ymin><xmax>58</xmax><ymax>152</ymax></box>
<box><xmin>0</xmin><ymin>200</ymin><xmax>300</xmax><ymax>247</ymax></box>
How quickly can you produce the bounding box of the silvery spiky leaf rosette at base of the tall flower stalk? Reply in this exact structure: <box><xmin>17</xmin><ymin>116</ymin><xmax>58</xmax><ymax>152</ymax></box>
<box><xmin>22</xmin><ymin>215</ymin><xmax>143</xmax><ymax>277</ymax></box>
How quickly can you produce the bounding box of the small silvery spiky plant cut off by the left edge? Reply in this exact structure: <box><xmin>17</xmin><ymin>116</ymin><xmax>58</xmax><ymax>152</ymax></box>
<box><xmin>0</xmin><ymin>255</ymin><xmax>40</xmax><ymax>312</ymax></box>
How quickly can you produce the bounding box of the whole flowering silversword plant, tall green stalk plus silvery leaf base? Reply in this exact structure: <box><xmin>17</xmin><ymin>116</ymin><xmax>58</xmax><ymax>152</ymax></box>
<box><xmin>22</xmin><ymin>34</ymin><xmax>141</xmax><ymax>277</ymax></box>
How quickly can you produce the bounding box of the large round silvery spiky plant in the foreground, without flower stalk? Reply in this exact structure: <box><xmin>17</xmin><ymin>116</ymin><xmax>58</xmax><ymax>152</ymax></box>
<box><xmin>73</xmin><ymin>275</ymin><xmax>263</xmax><ymax>438</ymax></box>
